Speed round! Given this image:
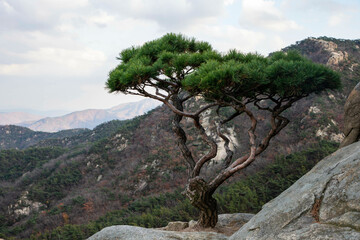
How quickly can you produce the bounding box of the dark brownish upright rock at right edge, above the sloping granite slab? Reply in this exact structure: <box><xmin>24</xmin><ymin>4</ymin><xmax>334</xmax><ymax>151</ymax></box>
<box><xmin>340</xmin><ymin>83</ymin><xmax>360</xmax><ymax>148</ymax></box>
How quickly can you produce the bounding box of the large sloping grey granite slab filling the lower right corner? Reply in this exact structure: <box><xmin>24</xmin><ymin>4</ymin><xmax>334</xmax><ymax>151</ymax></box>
<box><xmin>229</xmin><ymin>142</ymin><xmax>360</xmax><ymax>240</ymax></box>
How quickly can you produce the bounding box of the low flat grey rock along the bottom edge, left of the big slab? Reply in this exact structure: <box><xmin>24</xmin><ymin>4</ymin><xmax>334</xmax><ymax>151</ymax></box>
<box><xmin>88</xmin><ymin>225</ymin><xmax>228</xmax><ymax>240</ymax></box>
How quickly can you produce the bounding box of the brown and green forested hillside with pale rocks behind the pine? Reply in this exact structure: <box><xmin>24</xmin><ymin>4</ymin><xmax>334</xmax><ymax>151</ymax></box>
<box><xmin>0</xmin><ymin>38</ymin><xmax>360</xmax><ymax>239</ymax></box>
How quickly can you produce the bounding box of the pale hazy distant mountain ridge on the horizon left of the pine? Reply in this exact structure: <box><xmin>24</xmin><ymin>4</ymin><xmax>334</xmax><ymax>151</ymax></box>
<box><xmin>6</xmin><ymin>99</ymin><xmax>160</xmax><ymax>132</ymax></box>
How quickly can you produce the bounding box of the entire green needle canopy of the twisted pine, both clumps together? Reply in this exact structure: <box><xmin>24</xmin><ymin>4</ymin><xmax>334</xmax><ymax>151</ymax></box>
<box><xmin>107</xmin><ymin>34</ymin><xmax>340</xmax><ymax>103</ymax></box>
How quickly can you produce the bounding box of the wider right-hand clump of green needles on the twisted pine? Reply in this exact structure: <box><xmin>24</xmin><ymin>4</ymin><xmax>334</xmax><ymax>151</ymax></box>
<box><xmin>182</xmin><ymin>50</ymin><xmax>340</xmax><ymax>100</ymax></box>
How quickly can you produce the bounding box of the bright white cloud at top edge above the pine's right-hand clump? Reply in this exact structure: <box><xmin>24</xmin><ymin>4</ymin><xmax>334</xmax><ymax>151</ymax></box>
<box><xmin>240</xmin><ymin>0</ymin><xmax>300</xmax><ymax>31</ymax></box>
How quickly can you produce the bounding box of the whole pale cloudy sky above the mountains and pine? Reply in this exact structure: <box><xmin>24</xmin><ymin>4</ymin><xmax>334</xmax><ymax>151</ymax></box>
<box><xmin>0</xmin><ymin>0</ymin><xmax>360</xmax><ymax>113</ymax></box>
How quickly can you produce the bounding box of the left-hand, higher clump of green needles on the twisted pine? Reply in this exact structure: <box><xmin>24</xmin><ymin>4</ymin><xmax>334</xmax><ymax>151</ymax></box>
<box><xmin>107</xmin><ymin>34</ymin><xmax>221</xmax><ymax>94</ymax></box>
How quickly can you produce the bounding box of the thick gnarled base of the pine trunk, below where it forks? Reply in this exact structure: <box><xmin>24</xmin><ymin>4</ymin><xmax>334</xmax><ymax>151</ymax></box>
<box><xmin>185</xmin><ymin>177</ymin><xmax>218</xmax><ymax>228</ymax></box>
